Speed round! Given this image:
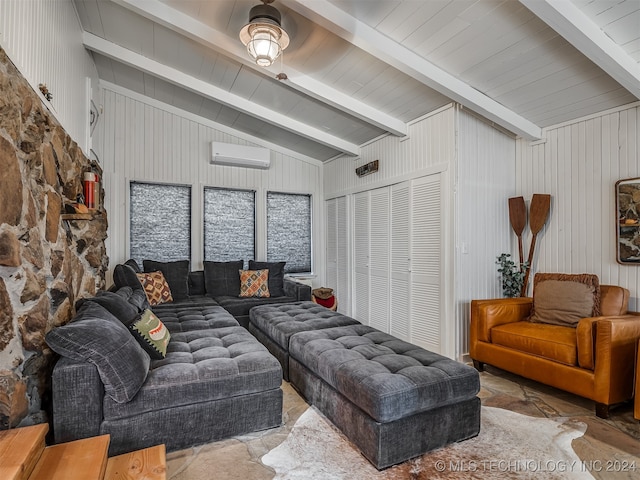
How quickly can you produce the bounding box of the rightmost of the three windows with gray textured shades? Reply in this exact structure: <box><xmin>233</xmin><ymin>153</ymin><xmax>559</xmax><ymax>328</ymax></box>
<box><xmin>267</xmin><ymin>192</ymin><xmax>311</xmax><ymax>273</ymax></box>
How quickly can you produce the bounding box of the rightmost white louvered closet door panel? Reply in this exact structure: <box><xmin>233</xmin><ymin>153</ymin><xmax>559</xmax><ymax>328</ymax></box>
<box><xmin>410</xmin><ymin>174</ymin><xmax>442</xmax><ymax>353</ymax></box>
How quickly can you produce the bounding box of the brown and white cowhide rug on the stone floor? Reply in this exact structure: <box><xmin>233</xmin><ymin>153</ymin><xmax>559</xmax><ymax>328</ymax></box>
<box><xmin>262</xmin><ymin>407</ymin><xmax>593</xmax><ymax>480</ymax></box>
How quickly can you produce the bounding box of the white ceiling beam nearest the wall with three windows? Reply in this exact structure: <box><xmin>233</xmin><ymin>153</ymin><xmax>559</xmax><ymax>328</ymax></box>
<box><xmin>82</xmin><ymin>32</ymin><xmax>360</xmax><ymax>156</ymax></box>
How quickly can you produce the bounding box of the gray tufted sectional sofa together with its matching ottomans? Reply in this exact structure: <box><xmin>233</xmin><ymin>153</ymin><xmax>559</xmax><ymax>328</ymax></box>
<box><xmin>47</xmin><ymin>265</ymin><xmax>480</xmax><ymax>469</ymax></box>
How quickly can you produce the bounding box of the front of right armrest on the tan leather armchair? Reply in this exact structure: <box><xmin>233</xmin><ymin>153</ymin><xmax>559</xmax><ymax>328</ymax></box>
<box><xmin>594</xmin><ymin>313</ymin><xmax>640</xmax><ymax>405</ymax></box>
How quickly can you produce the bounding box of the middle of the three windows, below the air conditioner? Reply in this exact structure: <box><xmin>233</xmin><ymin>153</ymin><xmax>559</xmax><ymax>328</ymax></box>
<box><xmin>204</xmin><ymin>188</ymin><xmax>256</xmax><ymax>262</ymax></box>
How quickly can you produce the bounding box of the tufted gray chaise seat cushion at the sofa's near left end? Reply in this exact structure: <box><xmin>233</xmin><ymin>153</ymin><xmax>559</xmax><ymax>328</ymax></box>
<box><xmin>104</xmin><ymin>325</ymin><xmax>282</xmax><ymax>420</ymax></box>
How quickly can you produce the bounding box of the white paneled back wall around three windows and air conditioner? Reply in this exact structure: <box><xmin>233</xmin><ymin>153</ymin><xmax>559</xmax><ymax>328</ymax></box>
<box><xmin>95</xmin><ymin>87</ymin><xmax>325</xmax><ymax>286</ymax></box>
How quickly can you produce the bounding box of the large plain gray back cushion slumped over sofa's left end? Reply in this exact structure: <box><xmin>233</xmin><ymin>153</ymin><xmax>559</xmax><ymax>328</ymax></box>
<box><xmin>46</xmin><ymin>302</ymin><xmax>150</xmax><ymax>403</ymax></box>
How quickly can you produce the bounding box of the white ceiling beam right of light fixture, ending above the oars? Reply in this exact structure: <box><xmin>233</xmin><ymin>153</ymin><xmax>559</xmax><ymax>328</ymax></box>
<box><xmin>280</xmin><ymin>0</ymin><xmax>542</xmax><ymax>140</ymax></box>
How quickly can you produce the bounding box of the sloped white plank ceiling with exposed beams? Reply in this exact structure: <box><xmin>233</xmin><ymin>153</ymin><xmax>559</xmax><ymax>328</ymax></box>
<box><xmin>75</xmin><ymin>0</ymin><xmax>640</xmax><ymax>160</ymax></box>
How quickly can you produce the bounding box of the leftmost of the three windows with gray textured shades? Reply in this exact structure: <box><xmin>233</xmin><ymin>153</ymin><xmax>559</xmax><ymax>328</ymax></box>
<box><xmin>129</xmin><ymin>182</ymin><xmax>191</xmax><ymax>265</ymax></box>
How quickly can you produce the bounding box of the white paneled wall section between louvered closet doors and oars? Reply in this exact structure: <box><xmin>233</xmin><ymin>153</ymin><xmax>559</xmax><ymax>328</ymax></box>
<box><xmin>455</xmin><ymin>109</ymin><xmax>529</xmax><ymax>354</ymax></box>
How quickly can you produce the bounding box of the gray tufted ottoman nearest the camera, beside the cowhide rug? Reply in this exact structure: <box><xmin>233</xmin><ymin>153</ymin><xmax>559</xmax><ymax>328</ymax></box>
<box><xmin>289</xmin><ymin>325</ymin><xmax>480</xmax><ymax>469</ymax></box>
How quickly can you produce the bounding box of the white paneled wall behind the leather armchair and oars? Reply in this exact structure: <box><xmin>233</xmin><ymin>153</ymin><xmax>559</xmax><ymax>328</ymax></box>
<box><xmin>516</xmin><ymin>103</ymin><xmax>640</xmax><ymax>310</ymax></box>
